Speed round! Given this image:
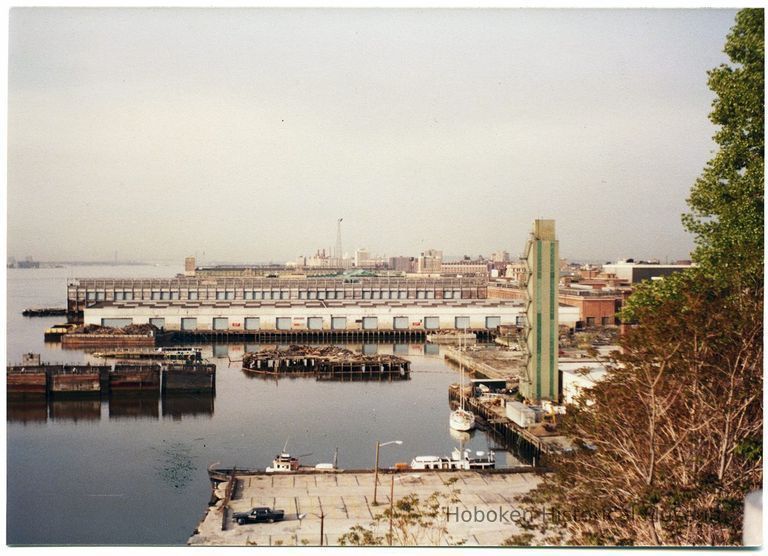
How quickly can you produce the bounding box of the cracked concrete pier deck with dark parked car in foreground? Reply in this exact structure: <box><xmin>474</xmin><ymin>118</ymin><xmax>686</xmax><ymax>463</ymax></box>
<box><xmin>187</xmin><ymin>470</ymin><xmax>539</xmax><ymax>546</ymax></box>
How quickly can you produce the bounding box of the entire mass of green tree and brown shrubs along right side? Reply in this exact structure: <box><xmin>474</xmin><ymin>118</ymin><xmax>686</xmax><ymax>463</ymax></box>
<box><xmin>509</xmin><ymin>9</ymin><xmax>764</xmax><ymax>545</ymax></box>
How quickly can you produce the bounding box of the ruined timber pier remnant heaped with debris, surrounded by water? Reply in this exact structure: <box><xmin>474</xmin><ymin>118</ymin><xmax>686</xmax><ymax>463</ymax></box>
<box><xmin>243</xmin><ymin>345</ymin><xmax>411</xmax><ymax>381</ymax></box>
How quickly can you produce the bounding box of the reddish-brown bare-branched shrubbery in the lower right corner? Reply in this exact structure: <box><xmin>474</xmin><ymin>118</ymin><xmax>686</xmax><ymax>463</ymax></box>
<box><xmin>504</xmin><ymin>273</ymin><xmax>763</xmax><ymax>545</ymax></box>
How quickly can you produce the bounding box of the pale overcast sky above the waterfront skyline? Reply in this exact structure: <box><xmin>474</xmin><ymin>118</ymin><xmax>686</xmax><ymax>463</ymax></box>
<box><xmin>8</xmin><ymin>8</ymin><xmax>735</xmax><ymax>262</ymax></box>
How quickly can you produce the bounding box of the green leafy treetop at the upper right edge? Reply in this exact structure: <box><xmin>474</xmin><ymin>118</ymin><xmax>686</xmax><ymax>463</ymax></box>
<box><xmin>683</xmin><ymin>9</ymin><xmax>765</xmax><ymax>292</ymax></box>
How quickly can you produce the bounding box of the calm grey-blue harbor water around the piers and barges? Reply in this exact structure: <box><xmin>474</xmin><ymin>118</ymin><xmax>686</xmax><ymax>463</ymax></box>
<box><xmin>6</xmin><ymin>266</ymin><xmax>517</xmax><ymax>545</ymax></box>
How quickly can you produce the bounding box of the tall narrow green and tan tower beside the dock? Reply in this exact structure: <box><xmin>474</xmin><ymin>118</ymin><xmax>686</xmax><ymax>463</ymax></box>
<box><xmin>520</xmin><ymin>220</ymin><xmax>560</xmax><ymax>402</ymax></box>
